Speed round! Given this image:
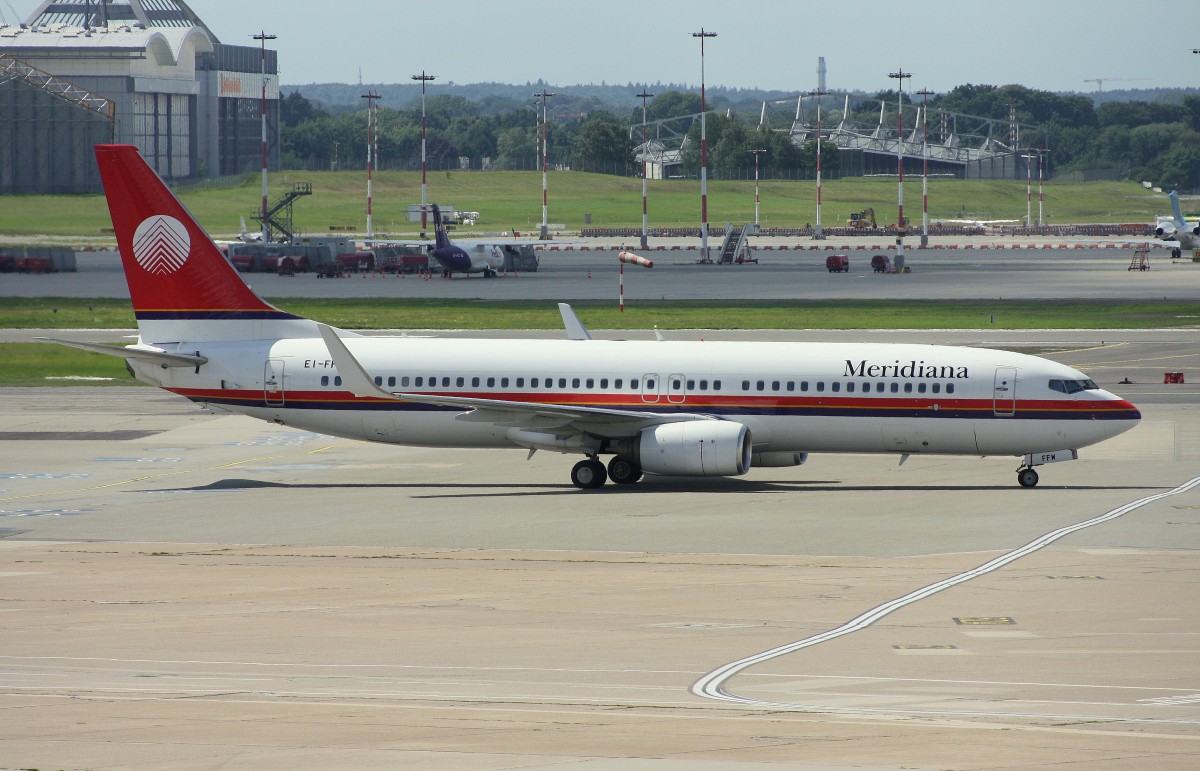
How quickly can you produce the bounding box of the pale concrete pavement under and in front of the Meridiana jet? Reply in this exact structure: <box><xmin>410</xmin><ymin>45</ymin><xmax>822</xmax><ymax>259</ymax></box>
<box><xmin>0</xmin><ymin>321</ymin><xmax>1200</xmax><ymax>770</ymax></box>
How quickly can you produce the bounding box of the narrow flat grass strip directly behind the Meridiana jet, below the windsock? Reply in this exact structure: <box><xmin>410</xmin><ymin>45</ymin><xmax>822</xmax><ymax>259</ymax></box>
<box><xmin>0</xmin><ymin>298</ymin><xmax>1195</xmax><ymax>329</ymax></box>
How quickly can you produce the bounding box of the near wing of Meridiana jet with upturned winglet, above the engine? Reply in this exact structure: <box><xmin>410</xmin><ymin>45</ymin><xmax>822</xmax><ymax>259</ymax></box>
<box><xmin>317</xmin><ymin>324</ymin><xmax>716</xmax><ymax>436</ymax></box>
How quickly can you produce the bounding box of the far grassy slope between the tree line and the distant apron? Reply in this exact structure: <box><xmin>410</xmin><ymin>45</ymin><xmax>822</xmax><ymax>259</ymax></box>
<box><xmin>0</xmin><ymin>172</ymin><xmax>1170</xmax><ymax>243</ymax></box>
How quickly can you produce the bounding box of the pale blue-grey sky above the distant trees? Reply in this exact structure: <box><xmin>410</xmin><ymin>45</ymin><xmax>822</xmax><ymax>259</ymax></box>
<box><xmin>9</xmin><ymin>0</ymin><xmax>1200</xmax><ymax>92</ymax></box>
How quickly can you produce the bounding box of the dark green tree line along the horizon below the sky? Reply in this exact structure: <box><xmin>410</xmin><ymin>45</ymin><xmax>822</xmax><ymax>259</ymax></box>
<box><xmin>280</xmin><ymin>84</ymin><xmax>1200</xmax><ymax>191</ymax></box>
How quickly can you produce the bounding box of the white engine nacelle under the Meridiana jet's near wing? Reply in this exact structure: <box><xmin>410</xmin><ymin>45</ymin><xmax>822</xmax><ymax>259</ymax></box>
<box><xmin>630</xmin><ymin>420</ymin><xmax>752</xmax><ymax>477</ymax></box>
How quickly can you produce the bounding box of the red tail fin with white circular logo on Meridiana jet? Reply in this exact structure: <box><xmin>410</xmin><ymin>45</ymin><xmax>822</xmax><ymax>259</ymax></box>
<box><xmin>96</xmin><ymin>144</ymin><xmax>298</xmax><ymax>321</ymax></box>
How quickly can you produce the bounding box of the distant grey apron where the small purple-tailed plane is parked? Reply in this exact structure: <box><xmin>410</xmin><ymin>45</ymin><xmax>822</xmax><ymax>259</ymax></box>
<box><xmin>2</xmin><ymin>239</ymin><xmax>1200</xmax><ymax>301</ymax></box>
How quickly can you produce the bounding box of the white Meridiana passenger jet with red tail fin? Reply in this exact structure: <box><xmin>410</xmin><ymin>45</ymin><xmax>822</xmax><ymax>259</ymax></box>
<box><xmin>44</xmin><ymin>145</ymin><xmax>1141</xmax><ymax>489</ymax></box>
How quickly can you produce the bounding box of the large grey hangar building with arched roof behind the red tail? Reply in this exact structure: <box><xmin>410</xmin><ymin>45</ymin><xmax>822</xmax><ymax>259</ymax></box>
<box><xmin>0</xmin><ymin>0</ymin><xmax>280</xmax><ymax>193</ymax></box>
